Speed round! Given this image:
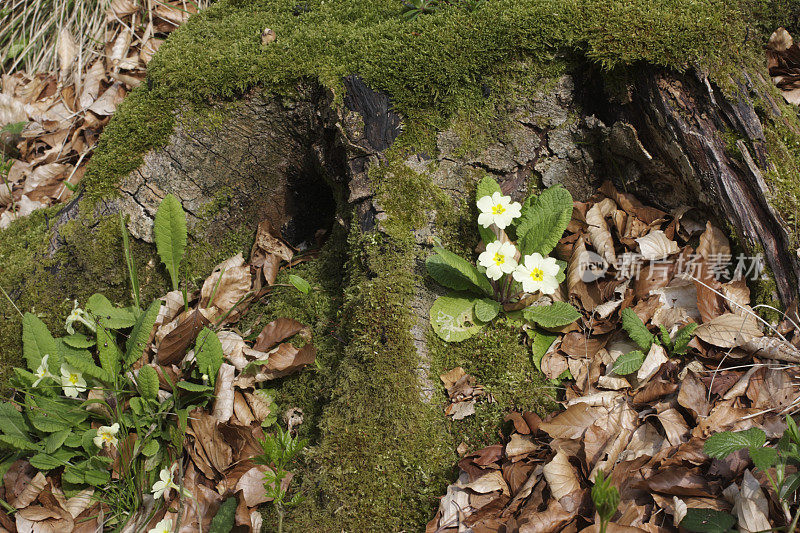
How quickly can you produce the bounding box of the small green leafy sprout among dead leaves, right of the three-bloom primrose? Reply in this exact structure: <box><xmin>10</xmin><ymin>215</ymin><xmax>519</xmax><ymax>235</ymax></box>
<box><xmin>614</xmin><ymin>308</ymin><xmax>697</xmax><ymax>376</ymax></box>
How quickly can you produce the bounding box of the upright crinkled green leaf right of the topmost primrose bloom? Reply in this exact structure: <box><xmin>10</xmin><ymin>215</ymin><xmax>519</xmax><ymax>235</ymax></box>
<box><xmin>517</xmin><ymin>186</ymin><xmax>572</xmax><ymax>256</ymax></box>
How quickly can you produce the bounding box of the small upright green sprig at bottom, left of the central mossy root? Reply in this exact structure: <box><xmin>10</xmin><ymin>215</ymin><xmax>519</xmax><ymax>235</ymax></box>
<box><xmin>254</xmin><ymin>426</ymin><xmax>308</xmax><ymax>533</ymax></box>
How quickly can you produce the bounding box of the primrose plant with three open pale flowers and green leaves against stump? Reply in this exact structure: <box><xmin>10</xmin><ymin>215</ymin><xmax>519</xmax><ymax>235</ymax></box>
<box><xmin>426</xmin><ymin>176</ymin><xmax>581</xmax><ymax>346</ymax></box>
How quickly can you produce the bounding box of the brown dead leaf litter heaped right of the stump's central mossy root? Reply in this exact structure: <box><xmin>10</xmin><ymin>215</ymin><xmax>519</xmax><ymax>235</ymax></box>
<box><xmin>427</xmin><ymin>182</ymin><xmax>800</xmax><ymax>533</ymax></box>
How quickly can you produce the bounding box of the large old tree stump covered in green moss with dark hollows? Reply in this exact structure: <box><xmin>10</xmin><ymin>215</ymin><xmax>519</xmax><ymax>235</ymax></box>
<box><xmin>0</xmin><ymin>1</ymin><xmax>800</xmax><ymax>531</ymax></box>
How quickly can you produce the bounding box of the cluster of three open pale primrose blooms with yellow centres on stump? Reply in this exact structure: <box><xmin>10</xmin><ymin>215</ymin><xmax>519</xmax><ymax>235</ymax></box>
<box><xmin>477</xmin><ymin>192</ymin><xmax>559</xmax><ymax>294</ymax></box>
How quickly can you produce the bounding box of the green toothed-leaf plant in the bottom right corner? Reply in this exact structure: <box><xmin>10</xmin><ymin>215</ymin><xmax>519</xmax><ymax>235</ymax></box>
<box><xmin>681</xmin><ymin>416</ymin><xmax>800</xmax><ymax>533</ymax></box>
